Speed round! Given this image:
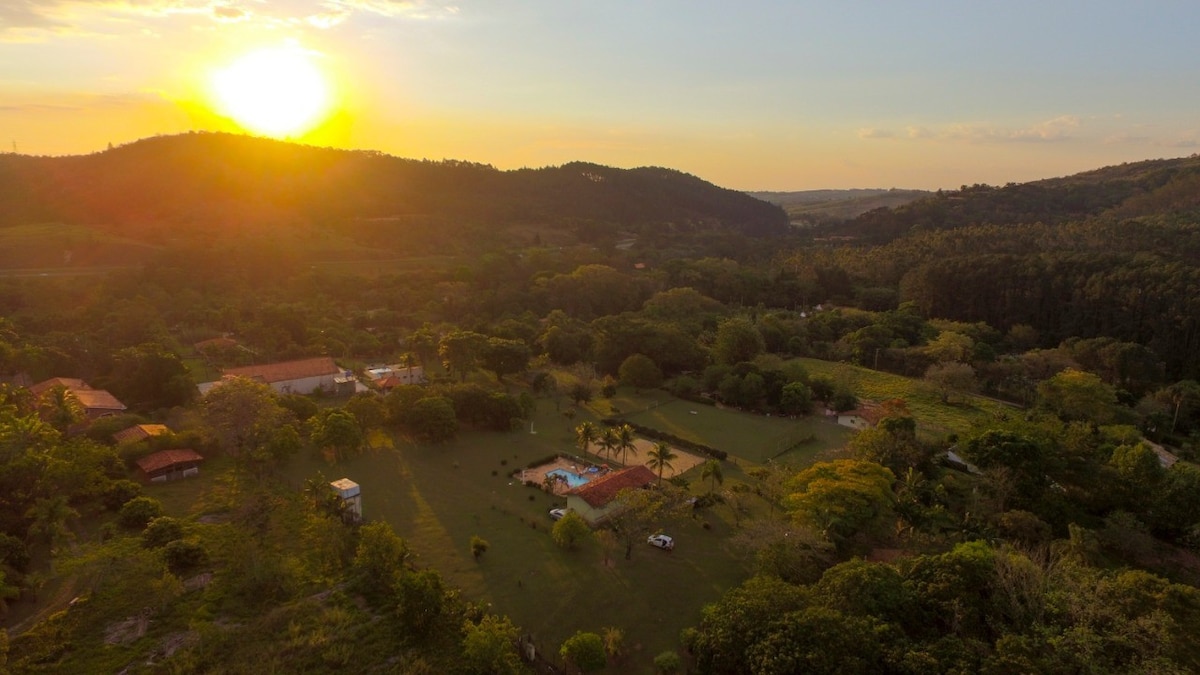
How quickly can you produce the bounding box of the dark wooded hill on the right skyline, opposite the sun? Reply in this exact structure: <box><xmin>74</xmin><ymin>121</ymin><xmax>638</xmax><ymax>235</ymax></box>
<box><xmin>835</xmin><ymin>155</ymin><xmax>1200</xmax><ymax>243</ymax></box>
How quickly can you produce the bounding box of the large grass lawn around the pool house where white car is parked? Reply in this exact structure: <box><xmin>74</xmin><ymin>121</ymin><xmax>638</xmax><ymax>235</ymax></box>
<box><xmin>289</xmin><ymin>400</ymin><xmax>748</xmax><ymax>673</ymax></box>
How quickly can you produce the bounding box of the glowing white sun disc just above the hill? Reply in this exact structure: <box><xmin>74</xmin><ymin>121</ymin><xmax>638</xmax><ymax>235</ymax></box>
<box><xmin>211</xmin><ymin>47</ymin><xmax>332</xmax><ymax>137</ymax></box>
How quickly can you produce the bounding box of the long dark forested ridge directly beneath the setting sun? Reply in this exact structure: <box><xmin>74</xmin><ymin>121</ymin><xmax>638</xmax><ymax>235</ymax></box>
<box><xmin>0</xmin><ymin>133</ymin><xmax>787</xmax><ymax>235</ymax></box>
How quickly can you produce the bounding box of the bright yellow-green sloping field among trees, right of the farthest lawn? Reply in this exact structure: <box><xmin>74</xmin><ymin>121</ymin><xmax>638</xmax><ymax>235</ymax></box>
<box><xmin>796</xmin><ymin>359</ymin><xmax>1010</xmax><ymax>436</ymax></box>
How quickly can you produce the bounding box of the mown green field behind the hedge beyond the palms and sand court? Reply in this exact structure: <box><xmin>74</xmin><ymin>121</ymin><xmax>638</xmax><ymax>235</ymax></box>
<box><xmin>613</xmin><ymin>393</ymin><xmax>851</xmax><ymax>464</ymax></box>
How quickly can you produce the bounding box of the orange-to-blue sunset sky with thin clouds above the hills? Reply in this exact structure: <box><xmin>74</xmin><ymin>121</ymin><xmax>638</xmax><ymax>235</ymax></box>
<box><xmin>0</xmin><ymin>0</ymin><xmax>1200</xmax><ymax>190</ymax></box>
